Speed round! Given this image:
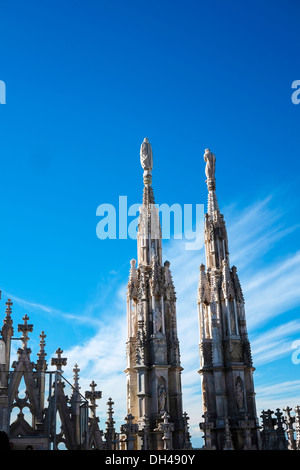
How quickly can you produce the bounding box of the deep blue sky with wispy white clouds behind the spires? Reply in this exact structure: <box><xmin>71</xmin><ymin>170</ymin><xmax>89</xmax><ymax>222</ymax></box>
<box><xmin>0</xmin><ymin>0</ymin><xmax>300</xmax><ymax>445</ymax></box>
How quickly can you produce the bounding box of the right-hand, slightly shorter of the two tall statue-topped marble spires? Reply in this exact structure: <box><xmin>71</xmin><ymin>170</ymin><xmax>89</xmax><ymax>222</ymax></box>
<box><xmin>198</xmin><ymin>149</ymin><xmax>260</xmax><ymax>449</ymax></box>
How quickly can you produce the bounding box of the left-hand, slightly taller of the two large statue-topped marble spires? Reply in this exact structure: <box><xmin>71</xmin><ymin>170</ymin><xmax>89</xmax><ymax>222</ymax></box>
<box><xmin>124</xmin><ymin>138</ymin><xmax>184</xmax><ymax>449</ymax></box>
